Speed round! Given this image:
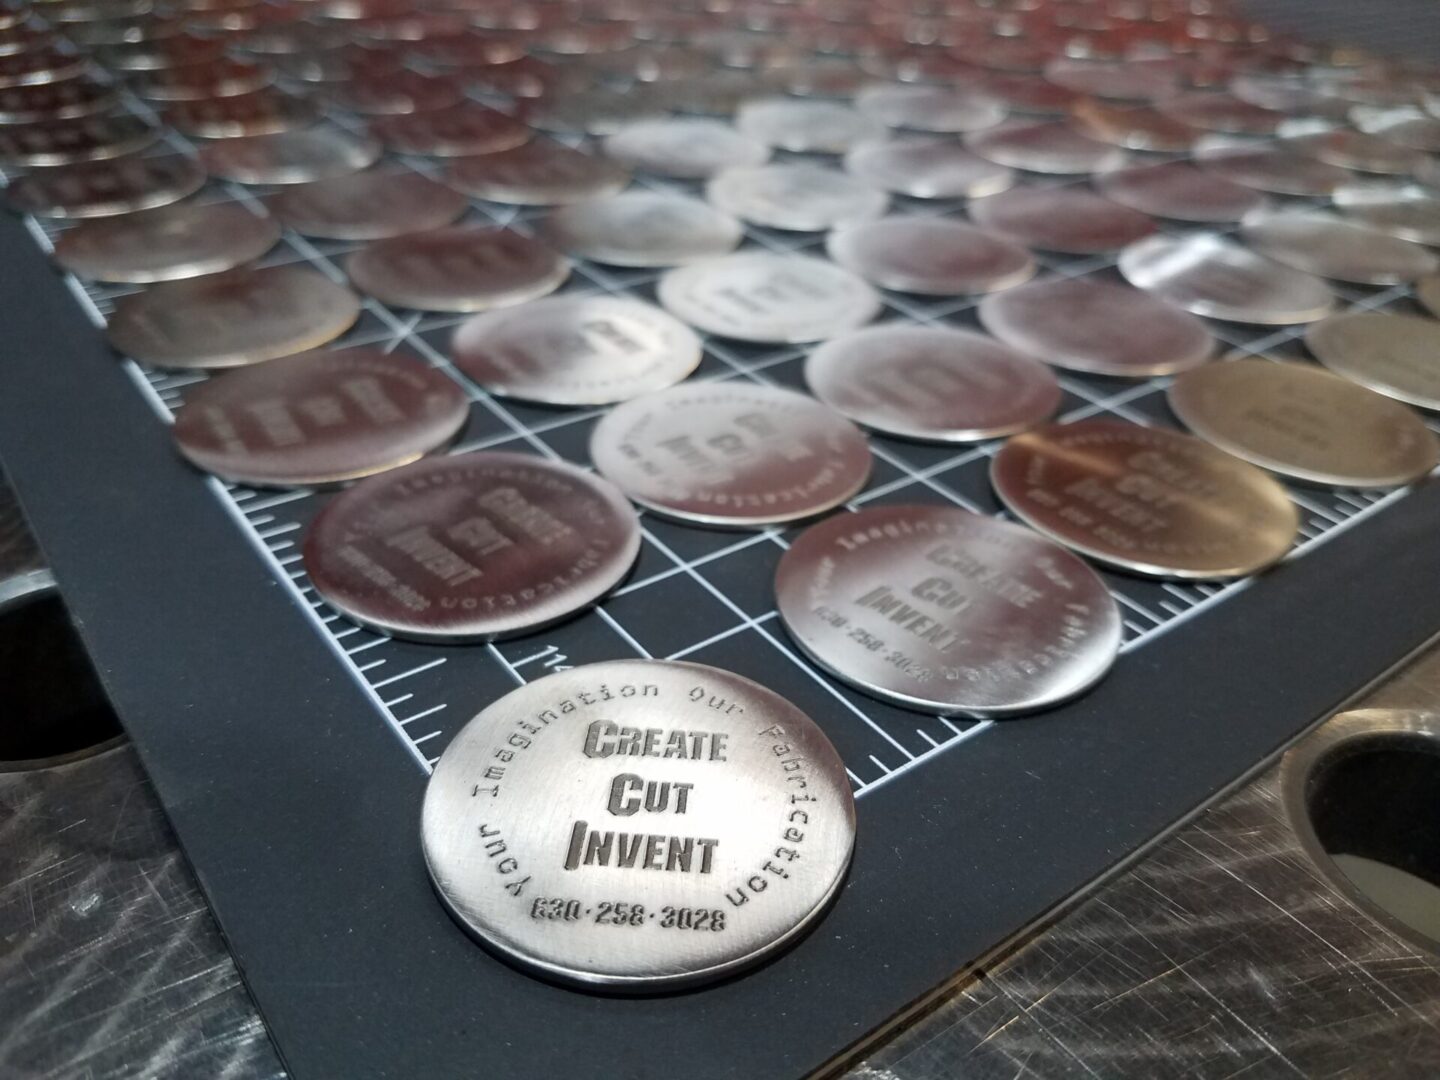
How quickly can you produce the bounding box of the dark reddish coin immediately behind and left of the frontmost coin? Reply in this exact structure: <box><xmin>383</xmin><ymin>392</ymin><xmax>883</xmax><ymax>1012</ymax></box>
<box><xmin>304</xmin><ymin>452</ymin><xmax>639</xmax><ymax>641</ymax></box>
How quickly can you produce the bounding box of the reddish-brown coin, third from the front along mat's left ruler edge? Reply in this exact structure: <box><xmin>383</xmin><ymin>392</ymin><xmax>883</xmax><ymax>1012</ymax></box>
<box><xmin>173</xmin><ymin>348</ymin><xmax>469</xmax><ymax>487</ymax></box>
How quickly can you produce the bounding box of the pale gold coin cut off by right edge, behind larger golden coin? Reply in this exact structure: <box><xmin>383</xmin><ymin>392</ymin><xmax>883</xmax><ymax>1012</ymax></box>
<box><xmin>1305</xmin><ymin>311</ymin><xmax>1440</xmax><ymax>412</ymax></box>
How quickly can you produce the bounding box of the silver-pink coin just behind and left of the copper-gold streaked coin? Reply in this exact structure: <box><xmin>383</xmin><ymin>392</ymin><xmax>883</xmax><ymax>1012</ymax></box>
<box><xmin>805</xmin><ymin>323</ymin><xmax>1060</xmax><ymax>442</ymax></box>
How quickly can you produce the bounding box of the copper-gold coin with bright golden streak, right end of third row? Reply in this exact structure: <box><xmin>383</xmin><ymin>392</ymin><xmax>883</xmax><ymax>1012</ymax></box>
<box><xmin>991</xmin><ymin>420</ymin><xmax>1299</xmax><ymax>579</ymax></box>
